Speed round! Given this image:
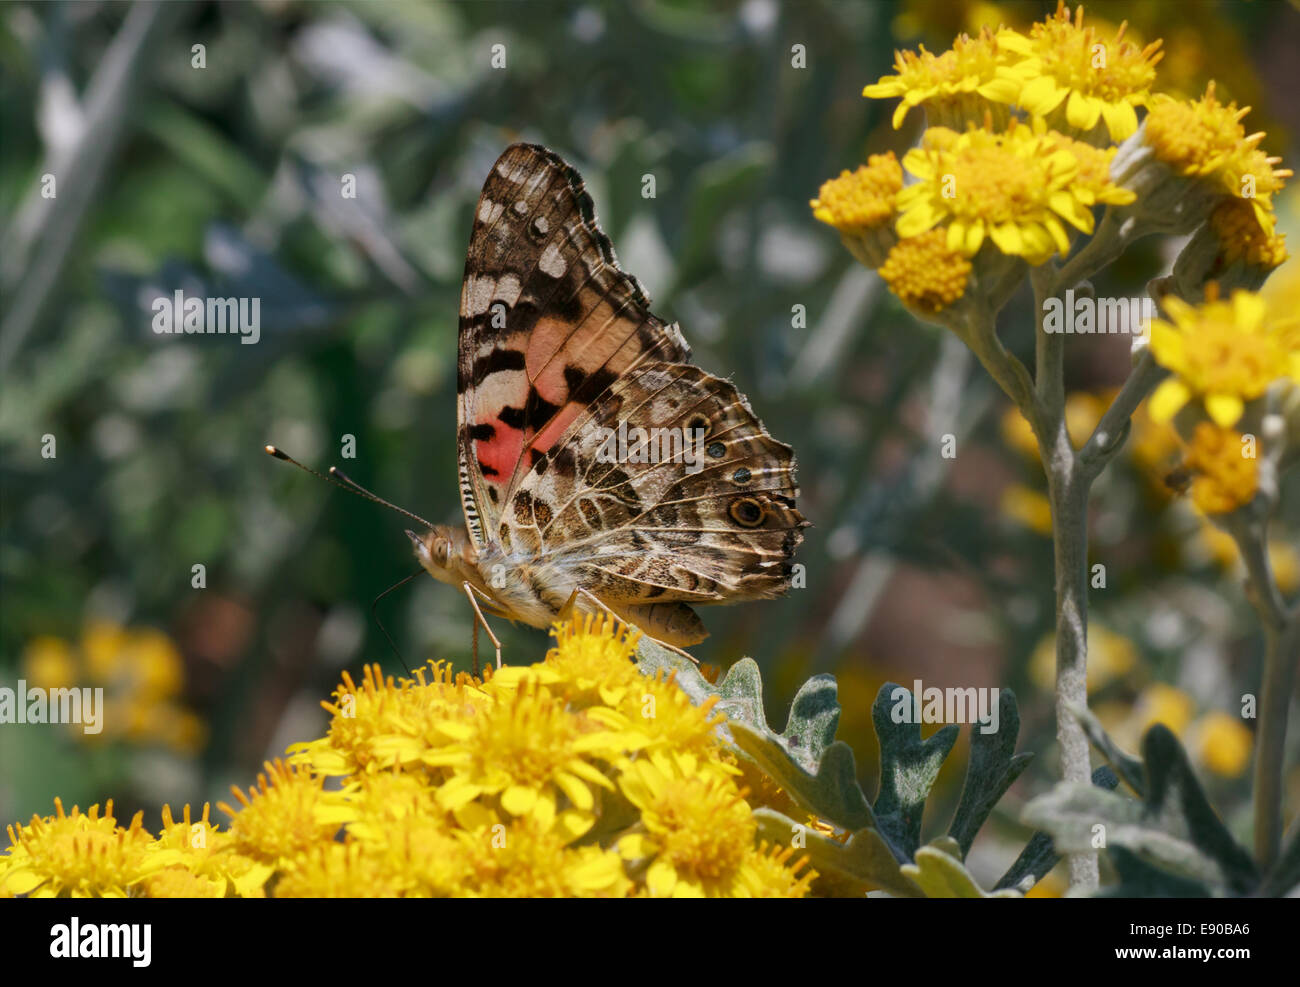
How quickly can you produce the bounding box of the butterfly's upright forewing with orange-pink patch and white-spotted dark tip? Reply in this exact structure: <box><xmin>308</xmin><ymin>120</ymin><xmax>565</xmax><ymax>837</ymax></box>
<box><xmin>458</xmin><ymin>144</ymin><xmax>690</xmax><ymax>547</ymax></box>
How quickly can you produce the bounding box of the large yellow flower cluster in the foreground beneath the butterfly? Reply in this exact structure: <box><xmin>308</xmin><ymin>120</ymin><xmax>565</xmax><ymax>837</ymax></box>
<box><xmin>0</xmin><ymin>616</ymin><xmax>815</xmax><ymax>897</ymax></box>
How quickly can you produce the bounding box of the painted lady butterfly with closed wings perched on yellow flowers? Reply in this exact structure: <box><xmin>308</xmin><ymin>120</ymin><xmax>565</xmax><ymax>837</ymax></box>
<box><xmin>273</xmin><ymin>143</ymin><xmax>809</xmax><ymax>666</ymax></box>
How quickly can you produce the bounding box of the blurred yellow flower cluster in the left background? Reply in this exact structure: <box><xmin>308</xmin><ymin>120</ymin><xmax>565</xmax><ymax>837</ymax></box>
<box><xmin>22</xmin><ymin>620</ymin><xmax>205</xmax><ymax>753</ymax></box>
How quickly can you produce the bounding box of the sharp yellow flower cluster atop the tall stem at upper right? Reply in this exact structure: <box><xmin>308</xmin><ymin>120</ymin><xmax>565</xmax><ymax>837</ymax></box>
<box><xmin>813</xmin><ymin>0</ymin><xmax>1291</xmax><ymax>282</ymax></box>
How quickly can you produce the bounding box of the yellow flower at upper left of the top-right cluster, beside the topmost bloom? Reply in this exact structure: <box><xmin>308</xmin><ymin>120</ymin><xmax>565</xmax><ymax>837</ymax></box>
<box><xmin>862</xmin><ymin>30</ymin><xmax>1017</xmax><ymax>130</ymax></box>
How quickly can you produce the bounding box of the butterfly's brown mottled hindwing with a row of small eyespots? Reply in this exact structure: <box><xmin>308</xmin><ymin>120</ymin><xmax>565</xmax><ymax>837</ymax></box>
<box><xmin>501</xmin><ymin>363</ymin><xmax>807</xmax><ymax>613</ymax></box>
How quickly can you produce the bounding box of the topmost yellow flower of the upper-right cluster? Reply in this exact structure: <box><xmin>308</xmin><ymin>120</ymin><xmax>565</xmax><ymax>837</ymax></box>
<box><xmin>997</xmin><ymin>0</ymin><xmax>1162</xmax><ymax>142</ymax></box>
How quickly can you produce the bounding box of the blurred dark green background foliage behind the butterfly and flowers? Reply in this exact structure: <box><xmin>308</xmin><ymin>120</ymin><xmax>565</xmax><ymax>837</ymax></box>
<box><xmin>0</xmin><ymin>0</ymin><xmax>1300</xmax><ymax>889</ymax></box>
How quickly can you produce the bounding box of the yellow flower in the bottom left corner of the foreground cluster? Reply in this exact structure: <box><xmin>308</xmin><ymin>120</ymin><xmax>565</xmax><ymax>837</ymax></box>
<box><xmin>0</xmin><ymin>798</ymin><xmax>174</xmax><ymax>897</ymax></box>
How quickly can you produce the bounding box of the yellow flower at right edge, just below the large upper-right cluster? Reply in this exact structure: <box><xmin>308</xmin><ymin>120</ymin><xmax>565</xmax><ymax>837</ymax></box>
<box><xmin>1151</xmin><ymin>290</ymin><xmax>1300</xmax><ymax>428</ymax></box>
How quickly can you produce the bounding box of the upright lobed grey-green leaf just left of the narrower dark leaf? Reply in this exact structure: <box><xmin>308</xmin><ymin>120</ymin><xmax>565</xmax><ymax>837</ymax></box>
<box><xmin>871</xmin><ymin>683</ymin><xmax>958</xmax><ymax>860</ymax></box>
